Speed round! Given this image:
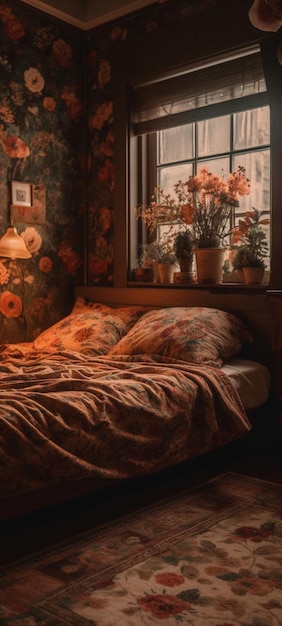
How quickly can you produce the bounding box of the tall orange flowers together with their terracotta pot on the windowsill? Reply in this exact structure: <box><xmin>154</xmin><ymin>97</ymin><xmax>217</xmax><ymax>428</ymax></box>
<box><xmin>174</xmin><ymin>166</ymin><xmax>250</xmax><ymax>283</ymax></box>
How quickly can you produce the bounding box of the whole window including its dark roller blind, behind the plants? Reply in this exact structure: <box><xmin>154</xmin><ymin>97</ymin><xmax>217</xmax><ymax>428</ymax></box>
<box><xmin>131</xmin><ymin>49</ymin><xmax>271</xmax><ymax>276</ymax></box>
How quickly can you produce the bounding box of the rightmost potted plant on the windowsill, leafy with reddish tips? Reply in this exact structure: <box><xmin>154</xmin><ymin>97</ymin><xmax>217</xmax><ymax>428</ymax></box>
<box><xmin>232</xmin><ymin>207</ymin><xmax>270</xmax><ymax>284</ymax></box>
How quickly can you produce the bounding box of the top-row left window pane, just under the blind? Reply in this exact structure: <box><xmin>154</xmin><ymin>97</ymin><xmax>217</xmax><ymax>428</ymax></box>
<box><xmin>159</xmin><ymin>124</ymin><xmax>194</xmax><ymax>164</ymax></box>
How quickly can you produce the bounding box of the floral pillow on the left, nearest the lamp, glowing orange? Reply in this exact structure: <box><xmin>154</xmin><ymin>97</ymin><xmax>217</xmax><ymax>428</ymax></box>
<box><xmin>33</xmin><ymin>297</ymin><xmax>147</xmax><ymax>355</ymax></box>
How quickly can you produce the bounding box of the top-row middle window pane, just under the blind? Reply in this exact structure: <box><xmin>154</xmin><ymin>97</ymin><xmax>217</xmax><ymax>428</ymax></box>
<box><xmin>198</xmin><ymin>115</ymin><xmax>230</xmax><ymax>157</ymax></box>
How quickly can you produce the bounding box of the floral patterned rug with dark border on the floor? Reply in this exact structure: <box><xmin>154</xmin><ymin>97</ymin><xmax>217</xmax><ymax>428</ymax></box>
<box><xmin>0</xmin><ymin>473</ymin><xmax>282</xmax><ymax>626</ymax></box>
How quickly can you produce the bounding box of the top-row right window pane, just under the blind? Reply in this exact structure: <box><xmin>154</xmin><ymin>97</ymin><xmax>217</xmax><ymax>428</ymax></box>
<box><xmin>234</xmin><ymin>107</ymin><xmax>270</xmax><ymax>150</ymax></box>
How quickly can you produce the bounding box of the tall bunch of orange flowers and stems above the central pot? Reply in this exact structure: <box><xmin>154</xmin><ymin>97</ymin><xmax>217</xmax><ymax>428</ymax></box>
<box><xmin>174</xmin><ymin>166</ymin><xmax>250</xmax><ymax>248</ymax></box>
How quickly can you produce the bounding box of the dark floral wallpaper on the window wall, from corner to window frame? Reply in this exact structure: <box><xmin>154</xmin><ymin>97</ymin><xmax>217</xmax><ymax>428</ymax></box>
<box><xmin>87</xmin><ymin>0</ymin><xmax>238</xmax><ymax>285</ymax></box>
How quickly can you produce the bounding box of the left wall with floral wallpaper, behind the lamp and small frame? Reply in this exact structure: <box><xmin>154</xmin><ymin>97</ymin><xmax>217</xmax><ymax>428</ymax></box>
<box><xmin>0</xmin><ymin>0</ymin><xmax>85</xmax><ymax>342</ymax></box>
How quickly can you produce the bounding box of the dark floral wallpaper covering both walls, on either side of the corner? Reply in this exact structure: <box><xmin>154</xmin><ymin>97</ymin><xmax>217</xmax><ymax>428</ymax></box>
<box><xmin>0</xmin><ymin>0</ymin><xmax>234</xmax><ymax>343</ymax></box>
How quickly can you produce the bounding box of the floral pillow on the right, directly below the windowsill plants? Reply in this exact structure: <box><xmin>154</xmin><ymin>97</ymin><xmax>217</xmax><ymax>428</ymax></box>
<box><xmin>109</xmin><ymin>307</ymin><xmax>252</xmax><ymax>367</ymax></box>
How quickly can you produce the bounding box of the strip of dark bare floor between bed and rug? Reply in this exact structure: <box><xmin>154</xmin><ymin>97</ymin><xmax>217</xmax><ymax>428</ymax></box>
<box><xmin>0</xmin><ymin>402</ymin><xmax>282</xmax><ymax>564</ymax></box>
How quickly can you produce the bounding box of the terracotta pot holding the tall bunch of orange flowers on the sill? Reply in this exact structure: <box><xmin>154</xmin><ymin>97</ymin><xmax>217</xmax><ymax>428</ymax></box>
<box><xmin>195</xmin><ymin>248</ymin><xmax>225</xmax><ymax>284</ymax></box>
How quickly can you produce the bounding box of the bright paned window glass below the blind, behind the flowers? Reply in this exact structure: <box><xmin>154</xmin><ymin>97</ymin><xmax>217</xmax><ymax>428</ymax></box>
<box><xmin>158</xmin><ymin>106</ymin><xmax>270</xmax><ymax>240</ymax></box>
